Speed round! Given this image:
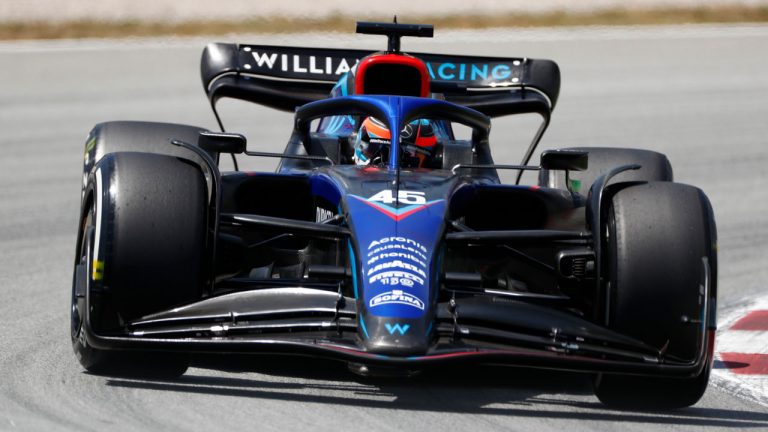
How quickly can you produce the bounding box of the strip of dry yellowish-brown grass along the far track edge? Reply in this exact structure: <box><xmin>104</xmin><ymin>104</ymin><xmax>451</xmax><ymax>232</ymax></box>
<box><xmin>0</xmin><ymin>6</ymin><xmax>768</xmax><ymax>40</ymax></box>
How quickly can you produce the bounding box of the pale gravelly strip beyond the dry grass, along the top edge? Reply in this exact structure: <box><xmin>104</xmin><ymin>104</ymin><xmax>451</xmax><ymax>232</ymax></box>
<box><xmin>0</xmin><ymin>0</ymin><xmax>766</xmax><ymax>23</ymax></box>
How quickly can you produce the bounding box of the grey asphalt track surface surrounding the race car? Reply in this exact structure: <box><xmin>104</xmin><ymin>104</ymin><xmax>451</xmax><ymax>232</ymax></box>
<box><xmin>0</xmin><ymin>25</ymin><xmax>768</xmax><ymax>431</ymax></box>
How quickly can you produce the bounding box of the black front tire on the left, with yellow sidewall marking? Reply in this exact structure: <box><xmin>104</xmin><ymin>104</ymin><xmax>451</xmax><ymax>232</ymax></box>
<box><xmin>72</xmin><ymin>153</ymin><xmax>208</xmax><ymax>377</ymax></box>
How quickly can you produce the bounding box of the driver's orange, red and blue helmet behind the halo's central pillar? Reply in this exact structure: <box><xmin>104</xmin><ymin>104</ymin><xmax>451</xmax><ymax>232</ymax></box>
<box><xmin>352</xmin><ymin>117</ymin><xmax>437</xmax><ymax>168</ymax></box>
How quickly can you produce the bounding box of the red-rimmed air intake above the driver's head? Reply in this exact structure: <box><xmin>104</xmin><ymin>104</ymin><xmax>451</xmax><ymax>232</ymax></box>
<box><xmin>355</xmin><ymin>54</ymin><xmax>429</xmax><ymax>97</ymax></box>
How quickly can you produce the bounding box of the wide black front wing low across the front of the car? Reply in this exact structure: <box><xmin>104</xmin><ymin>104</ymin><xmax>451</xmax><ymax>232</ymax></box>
<box><xmin>83</xmin><ymin>287</ymin><xmax>714</xmax><ymax>377</ymax></box>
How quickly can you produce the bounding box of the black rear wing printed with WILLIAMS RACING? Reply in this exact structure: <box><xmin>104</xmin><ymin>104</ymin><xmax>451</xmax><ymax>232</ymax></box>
<box><xmin>200</xmin><ymin>43</ymin><xmax>560</xmax><ymax>118</ymax></box>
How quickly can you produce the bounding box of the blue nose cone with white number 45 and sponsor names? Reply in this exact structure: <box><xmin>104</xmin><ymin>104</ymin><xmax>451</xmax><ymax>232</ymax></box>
<box><xmin>345</xmin><ymin>173</ymin><xmax>448</xmax><ymax>357</ymax></box>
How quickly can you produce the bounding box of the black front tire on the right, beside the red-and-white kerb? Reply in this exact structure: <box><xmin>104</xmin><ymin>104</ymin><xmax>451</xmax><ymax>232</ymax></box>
<box><xmin>595</xmin><ymin>182</ymin><xmax>717</xmax><ymax>409</ymax></box>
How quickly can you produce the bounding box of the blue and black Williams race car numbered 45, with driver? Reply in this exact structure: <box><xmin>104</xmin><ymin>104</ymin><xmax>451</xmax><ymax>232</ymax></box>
<box><xmin>71</xmin><ymin>23</ymin><xmax>717</xmax><ymax>408</ymax></box>
